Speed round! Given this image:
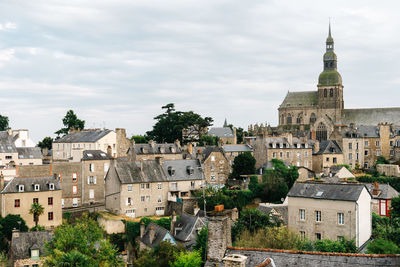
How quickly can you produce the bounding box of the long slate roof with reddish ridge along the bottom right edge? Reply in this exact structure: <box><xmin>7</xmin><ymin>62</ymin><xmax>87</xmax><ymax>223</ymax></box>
<box><xmin>226</xmin><ymin>247</ymin><xmax>400</xmax><ymax>267</ymax></box>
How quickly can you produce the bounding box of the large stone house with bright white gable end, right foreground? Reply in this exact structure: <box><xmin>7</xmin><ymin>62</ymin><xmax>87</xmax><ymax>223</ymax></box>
<box><xmin>287</xmin><ymin>182</ymin><xmax>372</xmax><ymax>247</ymax></box>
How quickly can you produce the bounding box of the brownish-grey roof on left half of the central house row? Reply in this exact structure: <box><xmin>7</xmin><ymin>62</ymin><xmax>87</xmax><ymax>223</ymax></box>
<box><xmin>115</xmin><ymin>160</ymin><xmax>167</xmax><ymax>184</ymax></box>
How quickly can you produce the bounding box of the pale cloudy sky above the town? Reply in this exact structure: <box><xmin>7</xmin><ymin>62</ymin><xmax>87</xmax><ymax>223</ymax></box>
<box><xmin>0</xmin><ymin>0</ymin><xmax>400</xmax><ymax>142</ymax></box>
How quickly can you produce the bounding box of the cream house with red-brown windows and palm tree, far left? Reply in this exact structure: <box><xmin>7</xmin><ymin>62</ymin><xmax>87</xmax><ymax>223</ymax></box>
<box><xmin>0</xmin><ymin>177</ymin><xmax>62</xmax><ymax>228</ymax></box>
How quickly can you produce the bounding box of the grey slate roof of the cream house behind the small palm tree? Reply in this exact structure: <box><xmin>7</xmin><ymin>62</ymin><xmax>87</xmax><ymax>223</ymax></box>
<box><xmin>1</xmin><ymin>176</ymin><xmax>61</xmax><ymax>194</ymax></box>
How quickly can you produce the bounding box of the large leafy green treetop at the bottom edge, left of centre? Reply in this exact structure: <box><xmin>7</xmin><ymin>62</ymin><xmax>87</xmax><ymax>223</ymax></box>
<box><xmin>45</xmin><ymin>214</ymin><xmax>123</xmax><ymax>267</ymax></box>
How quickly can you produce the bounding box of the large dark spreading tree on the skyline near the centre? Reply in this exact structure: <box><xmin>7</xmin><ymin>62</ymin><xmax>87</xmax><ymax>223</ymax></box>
<box><xmin>146</xmin><ymin>103</ymin><xmax>213</xmax><ymax>143</ymax></box>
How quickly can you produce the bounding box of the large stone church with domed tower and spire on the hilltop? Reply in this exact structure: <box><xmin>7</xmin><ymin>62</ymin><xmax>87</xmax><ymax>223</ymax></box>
<box><xmin>278</xmin><ymin>25</ymin><xmax>400</xmax><ymax>141</ymax></box>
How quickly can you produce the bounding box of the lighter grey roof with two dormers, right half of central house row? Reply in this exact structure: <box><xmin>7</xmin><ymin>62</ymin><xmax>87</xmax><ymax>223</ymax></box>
<box><xmin>162</xmin><ymin>159</ymin><xmax>204</xmax><ymax>181</ymax></box>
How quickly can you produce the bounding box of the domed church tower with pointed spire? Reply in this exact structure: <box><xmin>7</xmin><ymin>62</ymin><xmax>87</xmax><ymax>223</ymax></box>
<box><xmin>318</xmin><ymin>23</ymin><xmax>344</xmax><ymax>122</ymax></box>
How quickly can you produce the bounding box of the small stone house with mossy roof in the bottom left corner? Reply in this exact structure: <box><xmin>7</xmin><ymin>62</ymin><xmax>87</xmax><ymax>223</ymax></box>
<box><xmin>10</xmin><ymin>229</ymin><xmax>53</xmax><ymax>267</ymax></box>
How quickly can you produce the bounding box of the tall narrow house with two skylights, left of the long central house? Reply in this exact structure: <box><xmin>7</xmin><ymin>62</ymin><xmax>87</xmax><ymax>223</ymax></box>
<box><xmin>81</xmin><ymin>150</ymin><xmax>112</xmax><ymax>205</ymax></box>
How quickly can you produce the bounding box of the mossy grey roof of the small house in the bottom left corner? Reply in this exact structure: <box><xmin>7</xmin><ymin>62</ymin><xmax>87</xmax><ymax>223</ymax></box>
<box><xmin>11</xmin><ymin>231</ymin><xmax>53</xmax><ymax>260</ymax></box>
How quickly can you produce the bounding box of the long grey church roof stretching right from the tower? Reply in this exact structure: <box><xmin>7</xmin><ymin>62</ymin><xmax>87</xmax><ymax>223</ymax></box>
<box><xmin>342</xmin><ymin>108</ymin><xmax>400</xmax><ymax>125</ymax></box>
